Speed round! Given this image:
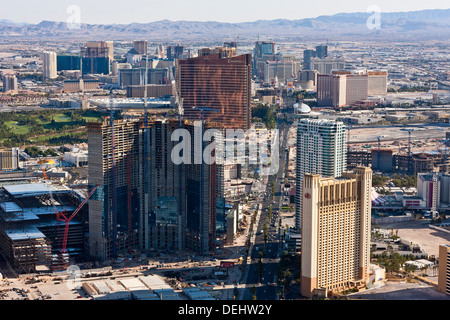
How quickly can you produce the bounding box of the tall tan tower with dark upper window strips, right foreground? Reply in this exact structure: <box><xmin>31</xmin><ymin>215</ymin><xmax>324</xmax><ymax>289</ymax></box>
<box><xmin>301</xmin><ymin>167</ymin><xmax>372</xmax><ymax>298</ymax></box>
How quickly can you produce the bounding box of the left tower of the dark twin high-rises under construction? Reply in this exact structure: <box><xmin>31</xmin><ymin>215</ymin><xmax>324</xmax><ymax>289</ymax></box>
<box><xmin>87</xmin><ymin>120</ymin><xmax>140</xmax><ymax>260</ymax></box>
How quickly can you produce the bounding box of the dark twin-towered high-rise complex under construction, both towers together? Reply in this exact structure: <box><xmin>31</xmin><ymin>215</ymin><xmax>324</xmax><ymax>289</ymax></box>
<box><xmin>88</xmin><ymin>118</ymin><xmax>216</xmax><ymax>260</ymax></box>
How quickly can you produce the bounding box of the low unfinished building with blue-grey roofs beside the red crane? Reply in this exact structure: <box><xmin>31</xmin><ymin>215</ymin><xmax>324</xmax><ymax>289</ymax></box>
<box><xmin>0</xmin><ymin>183</ymin><xmax>87</xmax><ymax>274</ymax></box>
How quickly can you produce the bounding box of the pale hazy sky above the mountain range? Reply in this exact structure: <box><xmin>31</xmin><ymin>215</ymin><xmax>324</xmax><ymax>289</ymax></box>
<box><xmin>0</xmin><ymin>0</ymin><xmax>450</xmax><ymax>24</ymax></box>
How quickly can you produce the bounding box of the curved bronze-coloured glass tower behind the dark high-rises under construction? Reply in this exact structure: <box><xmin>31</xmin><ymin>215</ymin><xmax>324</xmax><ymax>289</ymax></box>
<box><xmin>176</xmin><ymin>54</ymin><xmax>251</xmax><ymax>130</ymax></box>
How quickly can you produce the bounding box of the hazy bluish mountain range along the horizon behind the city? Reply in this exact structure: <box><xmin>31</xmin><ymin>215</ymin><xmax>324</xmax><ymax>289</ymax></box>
<box><xmin>0</xmin><ymin>9</ymin><xmax>450</xmax><ymax>41</ymax></box>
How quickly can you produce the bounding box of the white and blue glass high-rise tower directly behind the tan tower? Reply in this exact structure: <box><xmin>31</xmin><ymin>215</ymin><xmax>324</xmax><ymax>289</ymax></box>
<box><xmin>295</xmin><ymin>119</ymin><xmax>347</xmax><ymax>232</ymax></box>
